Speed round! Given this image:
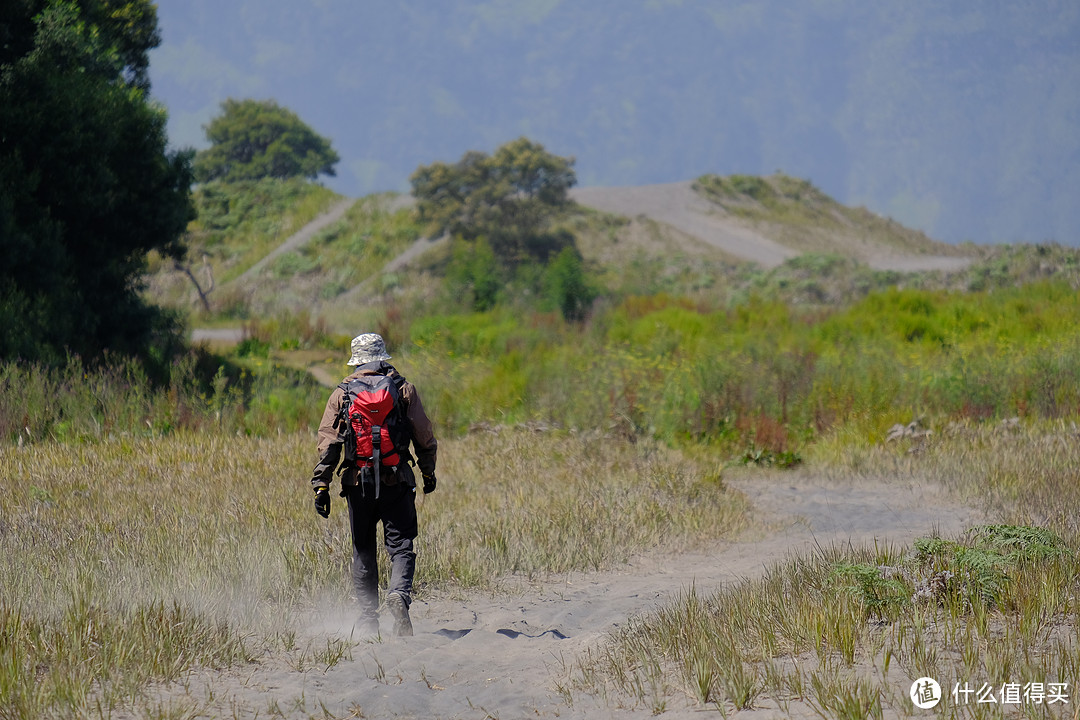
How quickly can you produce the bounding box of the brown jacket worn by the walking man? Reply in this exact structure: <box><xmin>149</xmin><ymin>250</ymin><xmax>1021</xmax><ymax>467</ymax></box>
<box><xmin>311</xmin><ymin>362</ymin><xmax>438</xmax><ymax>488</ymax></box>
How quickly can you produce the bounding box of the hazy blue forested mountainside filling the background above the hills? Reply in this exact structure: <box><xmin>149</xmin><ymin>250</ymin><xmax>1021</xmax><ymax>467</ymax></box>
<box><xmin>150</xmin><ymin>0</ymin><xmax>1080</xmax><ymax>245</ymax></box>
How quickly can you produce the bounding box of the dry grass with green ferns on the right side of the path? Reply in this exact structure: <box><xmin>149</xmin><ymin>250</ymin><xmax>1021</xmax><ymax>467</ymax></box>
<box><xmin>571</xmin><ymin>423</ymin><xmax>1080</xmax><ymax>718</ymax></box>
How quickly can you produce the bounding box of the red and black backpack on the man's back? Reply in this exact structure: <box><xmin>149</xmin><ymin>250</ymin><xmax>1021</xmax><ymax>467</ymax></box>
<box><xmin>339</xmin><ymin>375</ymin><xmax>411</xmax><ymax>498</ymax></box>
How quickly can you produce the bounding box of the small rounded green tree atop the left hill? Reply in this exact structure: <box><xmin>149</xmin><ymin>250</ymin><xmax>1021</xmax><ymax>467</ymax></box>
<box><xmin>194</xmin><ymin>98</ymin><xmax>340</xmax><ymax>182</ymax></box>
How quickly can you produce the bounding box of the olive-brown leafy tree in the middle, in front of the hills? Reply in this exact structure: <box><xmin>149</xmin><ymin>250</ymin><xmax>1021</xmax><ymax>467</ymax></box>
<box><xmin>409</xmin><ymin>137</ymin><xmax>577</xmax><ymax>267</ymax></box>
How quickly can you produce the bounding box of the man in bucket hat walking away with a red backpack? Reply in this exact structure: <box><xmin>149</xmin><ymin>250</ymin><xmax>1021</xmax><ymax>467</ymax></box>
<box><xmin>311</xmin><ymin>332</ymin><xmax>438</xmax><ymax>636</ymax></box>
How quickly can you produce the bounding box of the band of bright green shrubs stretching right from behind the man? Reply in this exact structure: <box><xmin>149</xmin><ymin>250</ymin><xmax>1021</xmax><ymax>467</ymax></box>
<box><xmin>397</xmin><ymin>278</ymin><xmax>1080</xmax><ymax>458</ymax></box>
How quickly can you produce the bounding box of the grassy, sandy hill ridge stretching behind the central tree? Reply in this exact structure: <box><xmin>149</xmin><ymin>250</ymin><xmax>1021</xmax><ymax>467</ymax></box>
<box><xmin>147</xmin><ymin>174</ymin><xmax>1078</xmax><ymax>347</ymax></box>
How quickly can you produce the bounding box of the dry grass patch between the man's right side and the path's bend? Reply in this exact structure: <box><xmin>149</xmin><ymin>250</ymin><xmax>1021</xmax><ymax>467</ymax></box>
<box><xmin>419</xmin><ymin>431</ymin><xmax>747</xmax><ymax>585</ymax></box>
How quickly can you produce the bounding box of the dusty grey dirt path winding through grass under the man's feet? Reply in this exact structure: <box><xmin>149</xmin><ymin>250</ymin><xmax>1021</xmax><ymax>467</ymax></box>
<box><xmin>143</xmin><ymin>471</ymin><xmax>981</xmax><ymax>718</ymax></box>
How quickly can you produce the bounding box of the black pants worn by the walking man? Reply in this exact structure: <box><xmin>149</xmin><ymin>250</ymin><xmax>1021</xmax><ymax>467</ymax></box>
<box><xmin>345</xmin><ymin>483</ymin><xmax>417</xmax><ymax>617</ymax></box>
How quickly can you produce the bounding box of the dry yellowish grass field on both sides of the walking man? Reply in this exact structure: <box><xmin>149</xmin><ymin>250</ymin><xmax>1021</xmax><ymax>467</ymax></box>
<box><xmin>0</xmin><ymin>431</ymin><xmax>745</xmax><ymax>718</ymax></box>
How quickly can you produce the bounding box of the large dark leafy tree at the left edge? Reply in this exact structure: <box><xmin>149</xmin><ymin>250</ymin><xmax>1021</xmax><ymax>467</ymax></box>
<box><xmin>0</xmin><ymin>0</ymin><xmax>192</xmax><ymax>362</ymax></box>
